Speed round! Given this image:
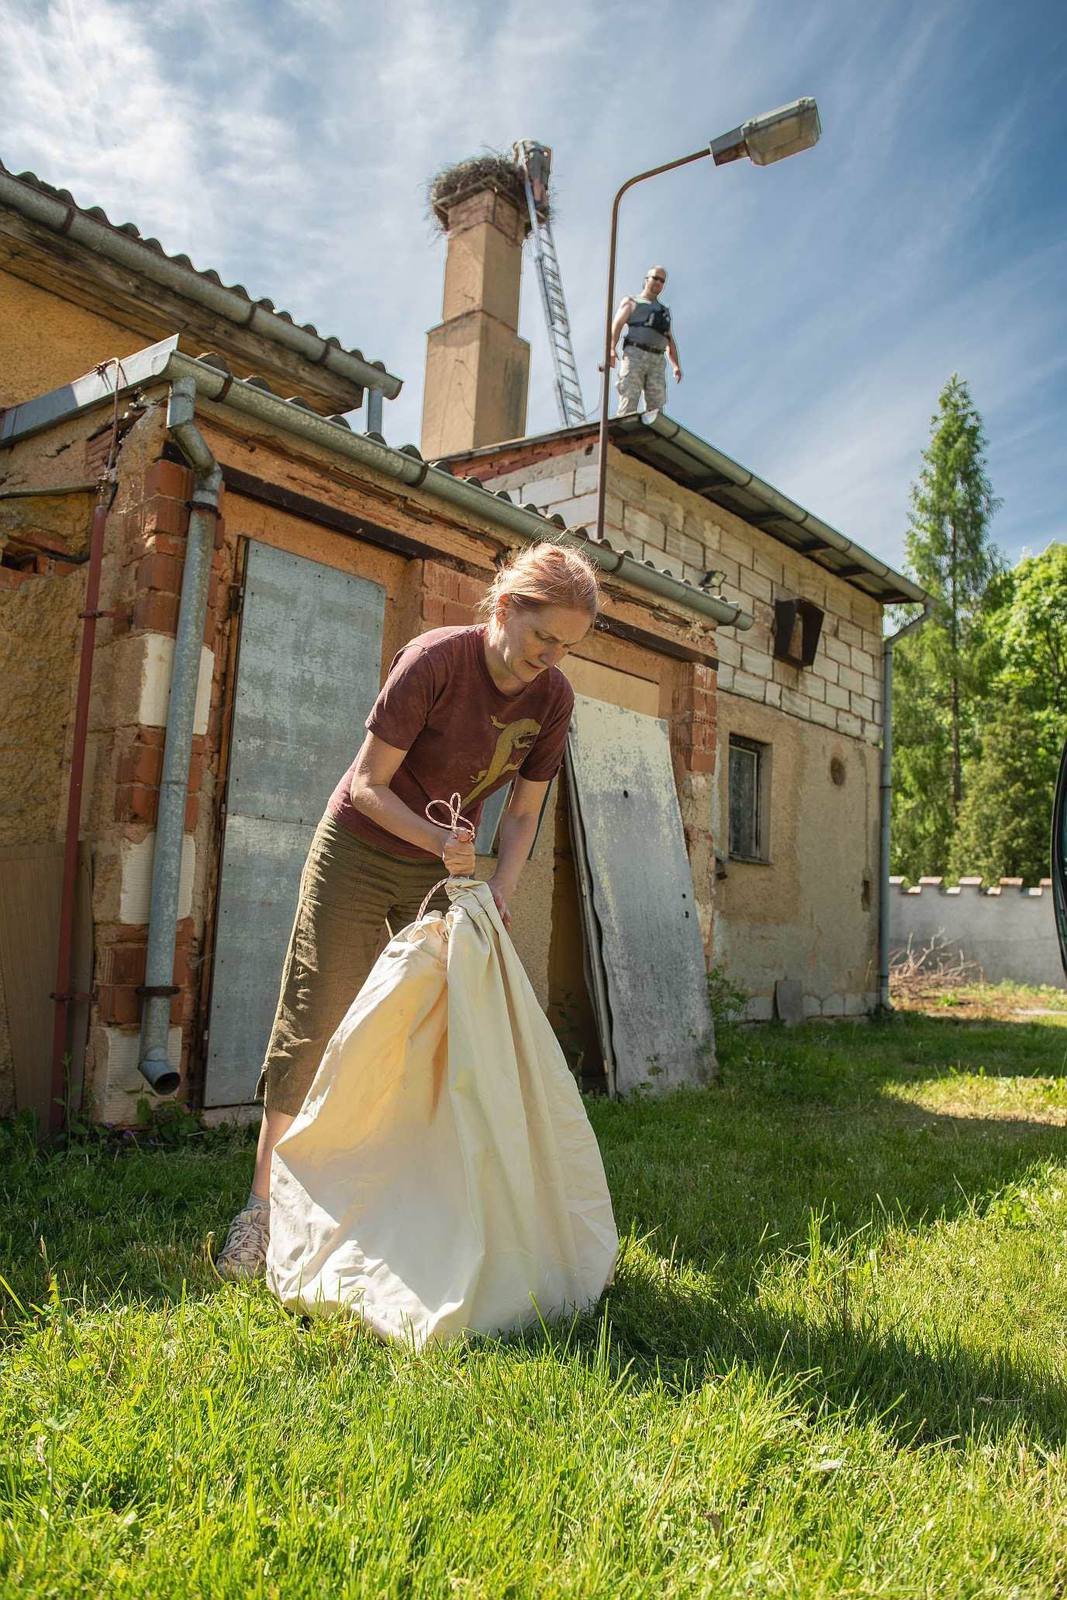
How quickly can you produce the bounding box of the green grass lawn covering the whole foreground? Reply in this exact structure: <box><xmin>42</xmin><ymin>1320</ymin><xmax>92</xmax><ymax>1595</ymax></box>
<box><xmin>0</xmin><ymin>1011</ymin><xmax>1067</xmax><ymax>1600</ymax></box>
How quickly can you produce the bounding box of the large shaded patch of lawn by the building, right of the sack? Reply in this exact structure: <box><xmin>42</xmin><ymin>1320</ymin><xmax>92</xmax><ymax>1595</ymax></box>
<box><xmin>593</xmin><ymin>1019</ymin><xmax>1067</xmax><ymax>1293</ymax></box>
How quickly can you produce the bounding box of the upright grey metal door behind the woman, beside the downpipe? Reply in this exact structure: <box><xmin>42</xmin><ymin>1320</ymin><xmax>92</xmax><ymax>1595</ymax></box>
<box><xmin>205</xmin><ymin>542</ymin><xmax>386</xmax><ymax>1106</ymax></box>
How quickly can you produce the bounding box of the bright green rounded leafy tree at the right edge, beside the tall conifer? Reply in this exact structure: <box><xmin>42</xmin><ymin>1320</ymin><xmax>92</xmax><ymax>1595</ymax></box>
<box><xmin>949</xmin><ymin>544</ymin><xmax>1067</xmax><ymax>883</ymax></box>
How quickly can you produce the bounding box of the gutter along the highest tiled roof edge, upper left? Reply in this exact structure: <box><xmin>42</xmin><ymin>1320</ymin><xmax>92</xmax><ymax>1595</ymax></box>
<box><xmin>0</xmin><ymin>170</ymin><xmax>403</xmax><ymax>400</ymax></box>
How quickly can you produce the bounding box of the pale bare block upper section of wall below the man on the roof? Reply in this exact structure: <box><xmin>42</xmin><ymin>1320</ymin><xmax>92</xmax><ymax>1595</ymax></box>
<box><xmin>486</xmin><ymin>450</ymin><xmax>881</xmax><ymax>744</ymax></box>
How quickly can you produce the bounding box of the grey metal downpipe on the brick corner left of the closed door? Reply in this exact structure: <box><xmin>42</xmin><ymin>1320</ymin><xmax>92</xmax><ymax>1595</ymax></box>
<box><xmin>138</xmin><ymin>378</ymin><xmax>222</xmax><ymax>1094</ymax></box>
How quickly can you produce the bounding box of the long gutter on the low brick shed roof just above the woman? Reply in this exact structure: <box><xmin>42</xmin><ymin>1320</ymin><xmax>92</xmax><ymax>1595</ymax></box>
<box><xmin>0</xmin><ymin>336</ymin><xmax>753</xmax><ymax>630</ymax></box>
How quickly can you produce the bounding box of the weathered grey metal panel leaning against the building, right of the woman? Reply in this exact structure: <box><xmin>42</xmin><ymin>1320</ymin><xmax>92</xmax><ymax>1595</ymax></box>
<box><xmin>569</xmin><ymin>694</ymin><xmax>715</xmax><ymax>1094</ymax></box>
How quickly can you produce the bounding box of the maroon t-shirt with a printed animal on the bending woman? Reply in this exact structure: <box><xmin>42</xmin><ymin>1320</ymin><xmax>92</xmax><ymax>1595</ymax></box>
<box><xmin>326</xmin><ymin>624</ymin><xmax>574</xmax><ymax>861</ymax></box>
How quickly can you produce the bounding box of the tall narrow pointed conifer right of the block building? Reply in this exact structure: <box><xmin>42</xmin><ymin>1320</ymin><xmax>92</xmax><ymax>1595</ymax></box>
<box><xmin>893</xmin><ymin>373</ymin><xmax>1003</xmax><ymax>877</ymax></box>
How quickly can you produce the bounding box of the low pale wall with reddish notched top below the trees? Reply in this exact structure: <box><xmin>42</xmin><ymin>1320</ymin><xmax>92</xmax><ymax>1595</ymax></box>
<box><xmin>889</xmin><ymin>878</ymin><xmax>1067</xmax><ymax>989</ymax></box>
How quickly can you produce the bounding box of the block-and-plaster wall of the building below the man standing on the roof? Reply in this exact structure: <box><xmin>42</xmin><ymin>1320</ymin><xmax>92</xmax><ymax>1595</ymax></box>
<box><xmin>477</xmin><ymin>442</ymin><xmax>881</xmax><ymax>1018</ymax></box>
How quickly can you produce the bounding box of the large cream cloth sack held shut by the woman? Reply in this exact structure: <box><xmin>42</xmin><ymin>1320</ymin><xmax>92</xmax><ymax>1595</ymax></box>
<box><xmin>267</xmin><ymin>880</ymin><xmax>619</xmax><ymax>1349</ymax></box>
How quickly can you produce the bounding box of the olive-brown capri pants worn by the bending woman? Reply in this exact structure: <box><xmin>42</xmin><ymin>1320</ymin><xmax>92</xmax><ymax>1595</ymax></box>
<box><xmin>256</xmin><ymin>816</ymin><xmax>448</xmax><ymax>1117</ymax></box>
